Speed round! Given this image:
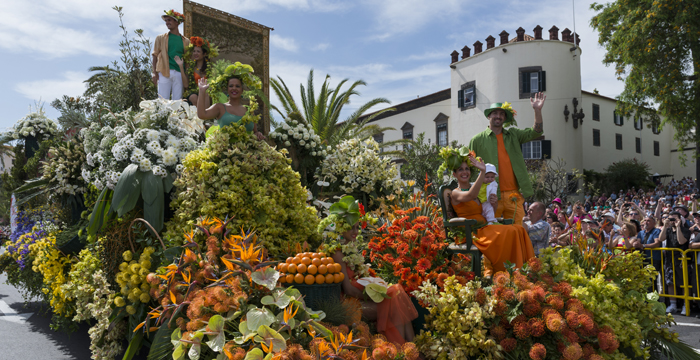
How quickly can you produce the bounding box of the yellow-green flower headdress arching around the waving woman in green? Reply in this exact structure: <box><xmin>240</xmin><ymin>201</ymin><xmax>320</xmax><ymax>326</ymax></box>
<box><xmin>209</xmin><ymin>61</ymin><xmax>262</xmax><ymax>125</ymax></box>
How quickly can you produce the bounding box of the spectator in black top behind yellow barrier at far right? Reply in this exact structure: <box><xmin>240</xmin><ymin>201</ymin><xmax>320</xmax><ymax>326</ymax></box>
<box><xmin>659</xmin><ymin>211</ymin><xmax>690</xmax><ymax>315</ymax></box>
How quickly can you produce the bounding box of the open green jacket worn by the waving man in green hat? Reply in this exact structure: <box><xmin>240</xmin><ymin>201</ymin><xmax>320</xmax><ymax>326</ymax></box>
<box><xmin>469</xmin><ymin>128</ymin><xmax>542</xmax><ymax>198</ymax></box>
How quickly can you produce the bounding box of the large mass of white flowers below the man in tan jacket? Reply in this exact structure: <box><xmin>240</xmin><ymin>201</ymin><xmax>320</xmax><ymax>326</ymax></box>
<box><xmin>80</xmin><ymin>99</ymin><xmax>204</xmax><ymax>190</ymax></box>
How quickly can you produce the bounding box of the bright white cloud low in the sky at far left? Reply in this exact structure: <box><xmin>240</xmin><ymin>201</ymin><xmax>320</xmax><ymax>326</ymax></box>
<box><xmin>14</xmin><ymin>71</ymin><xmax>89</xmax><ymax>103</ymax></box>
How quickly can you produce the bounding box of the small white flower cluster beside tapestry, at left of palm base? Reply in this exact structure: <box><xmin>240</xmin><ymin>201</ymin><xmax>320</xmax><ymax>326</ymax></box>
<box><xmin>270</xmin><ymin>118</ymin><xmax>328</xmax><ymax>158</ymax></box>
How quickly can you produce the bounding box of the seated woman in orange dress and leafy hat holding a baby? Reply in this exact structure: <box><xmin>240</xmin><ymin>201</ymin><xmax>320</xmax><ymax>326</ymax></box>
<box><xmin>452</xmin><ymin>155</ymin><xmax>535</xmax><ymax>276</ymax></box>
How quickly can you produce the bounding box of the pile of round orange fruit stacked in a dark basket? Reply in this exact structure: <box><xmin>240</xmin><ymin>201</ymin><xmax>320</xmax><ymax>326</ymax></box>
<box><xmin>277</xmin><ymin>252</ymin><xmax>345</xmax><ymax>285</ymax></box>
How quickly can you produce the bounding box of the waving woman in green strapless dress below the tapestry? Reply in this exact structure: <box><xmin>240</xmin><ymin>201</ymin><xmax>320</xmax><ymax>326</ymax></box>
<box><xmin>197</xmin><ymin>76</ymin><xmax>265</xmax><ymax>140</ymax></box>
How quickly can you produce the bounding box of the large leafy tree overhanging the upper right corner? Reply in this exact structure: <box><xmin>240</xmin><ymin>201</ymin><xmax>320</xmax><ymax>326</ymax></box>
<box><xmin>591</xmin><ymin>0</ymin><xmax>700</xmax><ymax>186</ymax></box>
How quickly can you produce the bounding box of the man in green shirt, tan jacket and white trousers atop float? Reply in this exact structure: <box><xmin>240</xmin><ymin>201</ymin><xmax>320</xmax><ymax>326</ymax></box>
<box><xmin>153</xmin><ymin>10</ymin><xmax>190</xmax><ymax>100</ymax></box>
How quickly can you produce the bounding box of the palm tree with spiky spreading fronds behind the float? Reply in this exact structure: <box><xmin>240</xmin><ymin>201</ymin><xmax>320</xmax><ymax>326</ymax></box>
<box><xmin>270</xmin><ymin>69</ymin><xmax>410</xmax><ymax>155</ymax></box>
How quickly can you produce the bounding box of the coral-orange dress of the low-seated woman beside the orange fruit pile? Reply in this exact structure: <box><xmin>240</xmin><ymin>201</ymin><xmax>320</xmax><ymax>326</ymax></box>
<box><xmin>345</xmin><ymin>265</ymin><xmax>418</xmax><ymax>345</ymax></box>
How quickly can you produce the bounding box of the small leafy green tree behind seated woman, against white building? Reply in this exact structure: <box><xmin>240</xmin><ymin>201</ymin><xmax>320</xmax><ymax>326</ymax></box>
<box><xmin>401</xmin><ymin>133</ymin><xmax>459</xmax><ymax>194</ymax></box>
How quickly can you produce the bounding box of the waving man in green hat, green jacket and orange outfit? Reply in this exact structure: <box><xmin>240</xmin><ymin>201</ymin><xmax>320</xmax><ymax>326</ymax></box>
<box><xmin>469</xmin><ymin>92</ymin><xmax>547</xmax><ymax>225</ymax></box>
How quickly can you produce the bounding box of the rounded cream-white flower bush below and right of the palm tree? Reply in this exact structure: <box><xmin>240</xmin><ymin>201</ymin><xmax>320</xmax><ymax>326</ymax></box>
<box><xmin>316</xmin><ymin>139</ymin><xmax>403</xmax><ymax>196</ymax></box>
